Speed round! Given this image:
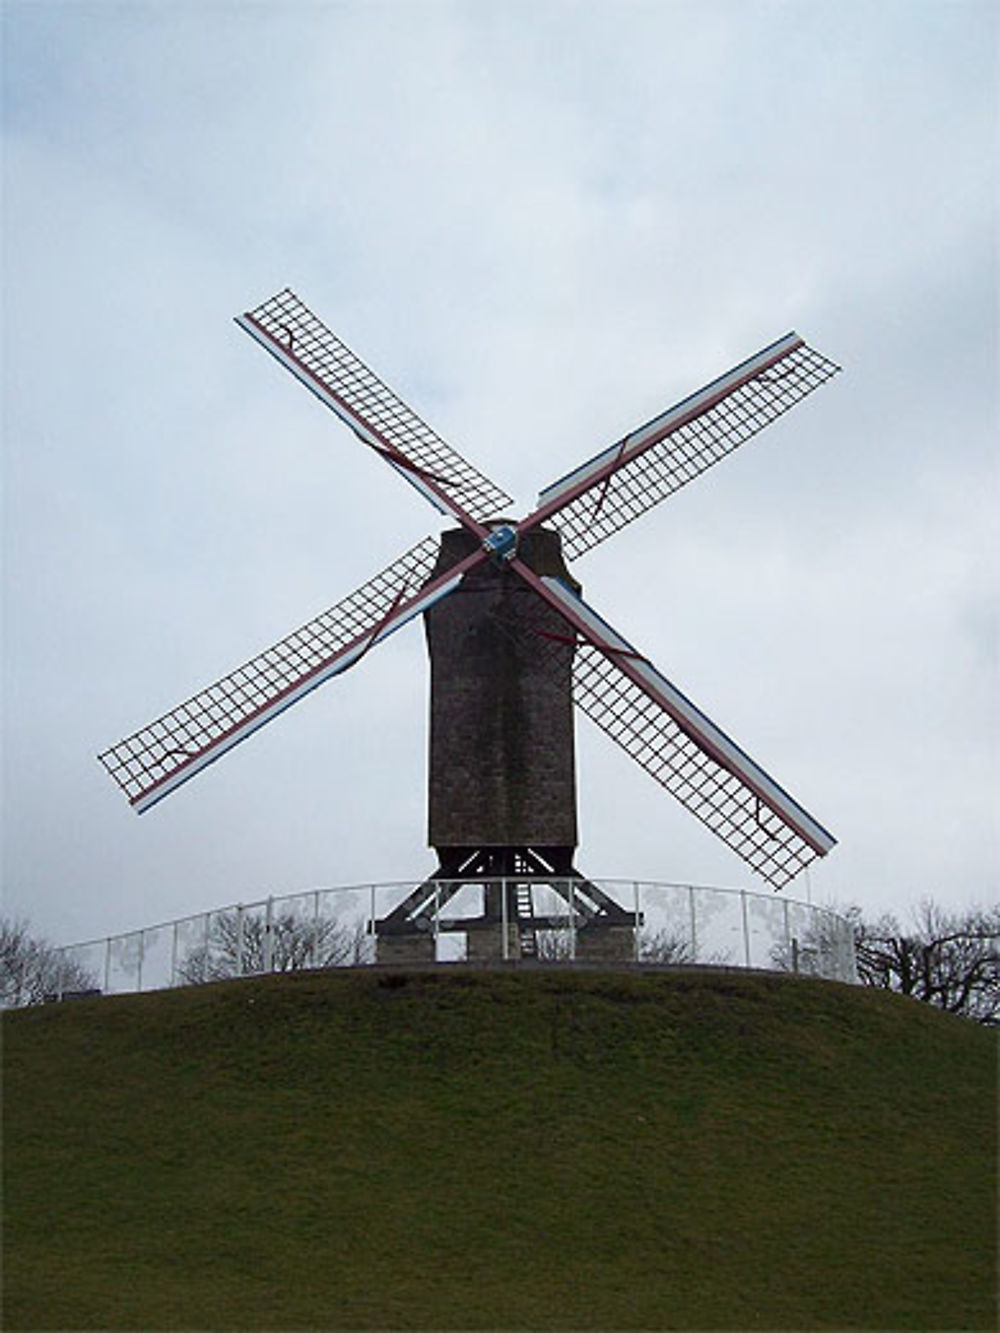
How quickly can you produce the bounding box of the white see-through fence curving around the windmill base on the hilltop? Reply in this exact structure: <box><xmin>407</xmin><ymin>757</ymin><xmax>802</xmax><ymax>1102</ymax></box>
<box><xmin>55</xmin><ymin>880</ymin><xmax>857</xmax><ymax>998</ymax></box>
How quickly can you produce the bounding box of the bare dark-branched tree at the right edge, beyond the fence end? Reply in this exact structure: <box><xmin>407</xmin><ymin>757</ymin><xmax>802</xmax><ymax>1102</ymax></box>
<box><xmin>849</xmin><ymin>901</ymin><xmax>1000</xmax><ymax>1026</ymax></box>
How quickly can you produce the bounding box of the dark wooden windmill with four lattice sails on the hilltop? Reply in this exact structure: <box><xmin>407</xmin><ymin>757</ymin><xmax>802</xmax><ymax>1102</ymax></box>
<box><xmin>99</xmin><ymin>289</ymin><xmax>839</xmax><ymax>957</ymax></box>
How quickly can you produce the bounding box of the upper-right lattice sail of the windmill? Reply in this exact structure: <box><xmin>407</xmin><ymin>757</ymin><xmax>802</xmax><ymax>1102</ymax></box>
<box><xmin>521</xmin><ymin>333</ymin><xmax>840</xmax><ymax>559</ymax></box>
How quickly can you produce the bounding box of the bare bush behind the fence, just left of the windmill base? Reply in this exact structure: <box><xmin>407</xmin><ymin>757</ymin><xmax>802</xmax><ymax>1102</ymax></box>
<box><xmin>177</xmin><ymin>908</ymin><xmax>371</xmax><ymax>982</ymax></box>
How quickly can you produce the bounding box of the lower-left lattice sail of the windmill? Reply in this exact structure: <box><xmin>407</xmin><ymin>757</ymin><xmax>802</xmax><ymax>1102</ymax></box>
<box><xmin>97</xmin><ymin>537</ymin><xmax>445</xmax><ymax>812</ymax></box>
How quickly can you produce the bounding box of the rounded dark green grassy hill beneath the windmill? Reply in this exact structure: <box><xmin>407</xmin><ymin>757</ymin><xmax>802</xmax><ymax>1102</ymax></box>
<box><xmin>4</xmin><ymin>968</ymin><xmax>996</xmax><ymax>1330</ymax></box>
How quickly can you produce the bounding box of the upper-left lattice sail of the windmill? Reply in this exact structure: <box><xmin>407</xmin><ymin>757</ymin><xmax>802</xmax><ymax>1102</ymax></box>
<box><xmin>236</xmin><ymin>288</ymin><xmax>512</xmax><ymax>523</ymax></box>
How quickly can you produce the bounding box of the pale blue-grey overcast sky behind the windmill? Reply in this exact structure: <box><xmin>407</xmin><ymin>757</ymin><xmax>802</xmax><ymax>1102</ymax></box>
<box><xmin>3</xmin><ymin>0</ymin><xmax>1000</xmax><ymax>942</ymax></box>
